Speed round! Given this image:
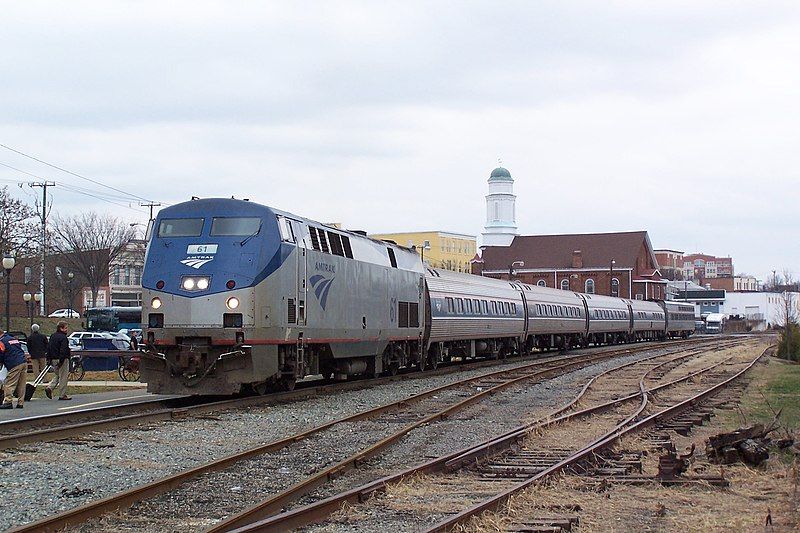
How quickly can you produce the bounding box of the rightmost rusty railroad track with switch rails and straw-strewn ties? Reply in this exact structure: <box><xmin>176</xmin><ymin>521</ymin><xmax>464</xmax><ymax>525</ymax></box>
<box><xmin>220</xmin><ymin>338</ymin><xmax>763</xmax><ymax>532</ymax></box>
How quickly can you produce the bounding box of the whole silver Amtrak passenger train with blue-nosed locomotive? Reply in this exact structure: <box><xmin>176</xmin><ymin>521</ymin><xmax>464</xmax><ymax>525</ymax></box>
<box><xmin>142</xmin><ymin>199</ymin><xmax>694</xmax><ymax>394</ymax></box>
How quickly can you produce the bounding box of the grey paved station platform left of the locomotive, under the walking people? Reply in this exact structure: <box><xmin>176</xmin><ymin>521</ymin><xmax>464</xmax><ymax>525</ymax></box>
<box><xmin>0</xmin><ymin>381</ymin><xmax>181</xmax><ymax>425</ymax></box>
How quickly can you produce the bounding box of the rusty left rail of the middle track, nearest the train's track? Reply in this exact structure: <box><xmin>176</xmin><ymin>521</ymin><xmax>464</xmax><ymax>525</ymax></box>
<box><xmin>4</xmin><ymin>339</ymin><xmax>688</xmax><ymax>532</ymax></box>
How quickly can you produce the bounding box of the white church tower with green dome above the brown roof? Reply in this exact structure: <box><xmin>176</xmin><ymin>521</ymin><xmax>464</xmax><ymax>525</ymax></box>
<box><xmin>482</xmin><ymin>167</ymin><xmax>517</xmax><ymax>246</ymax></box>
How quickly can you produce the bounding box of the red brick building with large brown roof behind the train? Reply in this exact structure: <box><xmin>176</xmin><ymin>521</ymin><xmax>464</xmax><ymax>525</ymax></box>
<box><xmin>472</xmin><ymin>231</ymin><xmax>667</xmax><ymax>299</ymax></box>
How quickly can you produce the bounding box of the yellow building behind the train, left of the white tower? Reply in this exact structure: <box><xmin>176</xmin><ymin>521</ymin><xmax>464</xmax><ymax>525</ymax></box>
<box><xmin>370</xmin><ymin>231</ymin><xmax>477</xmax><ymax>272</ymax></box>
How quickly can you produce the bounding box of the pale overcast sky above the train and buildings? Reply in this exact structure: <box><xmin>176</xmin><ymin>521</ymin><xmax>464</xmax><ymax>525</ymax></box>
<box><xmin>0</xmin><ymin>0</ymin><xmax>800</xmax><ymax>278</ymax></box>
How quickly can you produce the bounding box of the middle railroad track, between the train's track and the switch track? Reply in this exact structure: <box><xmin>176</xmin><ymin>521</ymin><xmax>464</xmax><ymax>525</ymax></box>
<box><xmin>6</xmin><ymin>341</ymin><xmax>716</xmax><ymax>531</ymax></box>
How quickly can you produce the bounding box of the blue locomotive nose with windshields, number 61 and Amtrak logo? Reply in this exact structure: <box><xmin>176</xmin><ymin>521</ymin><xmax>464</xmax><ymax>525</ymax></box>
<box><xmin>142</xmin><ymin>199</ymin><xmax>282</xmax><ymax>298</ymax></box>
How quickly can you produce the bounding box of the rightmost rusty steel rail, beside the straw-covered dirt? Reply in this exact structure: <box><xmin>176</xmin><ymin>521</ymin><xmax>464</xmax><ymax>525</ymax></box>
<box><xmin>426</xmin><ymin>346</ymin><xmax>771</xmax><ymax>533</ymax></box>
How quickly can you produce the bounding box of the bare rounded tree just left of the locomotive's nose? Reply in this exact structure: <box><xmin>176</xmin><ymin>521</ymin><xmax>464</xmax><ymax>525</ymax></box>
<box><xmin>53</xmin><ymin>212</ymin><xmax>135</xmax><ymax>307</ymax></box>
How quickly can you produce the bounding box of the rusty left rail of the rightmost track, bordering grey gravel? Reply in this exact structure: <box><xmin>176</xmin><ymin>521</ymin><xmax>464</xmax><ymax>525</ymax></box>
<box><xmin>231</xmin><ymin>338</ymin><xmax>752</xmax><ymax>533</ymax></box>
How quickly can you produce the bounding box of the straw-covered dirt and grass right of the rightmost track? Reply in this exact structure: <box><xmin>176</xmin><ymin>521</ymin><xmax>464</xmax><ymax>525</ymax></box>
<box><xmin>468</xmin><ymin>352</ymin><xmax>800</xmax><ymax>533</ymax></box>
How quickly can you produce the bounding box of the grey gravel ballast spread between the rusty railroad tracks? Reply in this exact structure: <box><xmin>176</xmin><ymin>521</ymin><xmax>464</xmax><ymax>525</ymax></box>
<box><xmin>0</xmin><ymin>345</ymin><xmax>688</xmax><ymax>531</ymax></box>
